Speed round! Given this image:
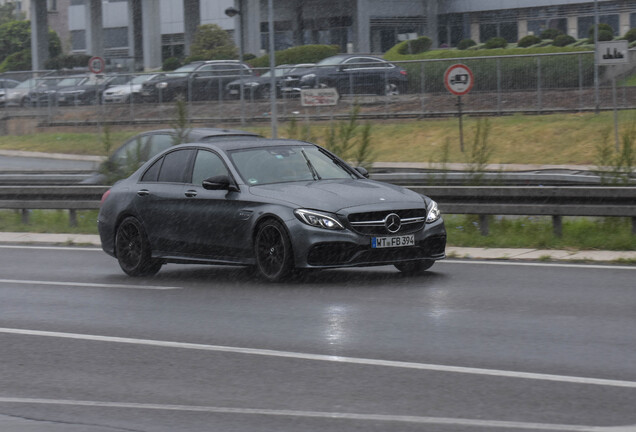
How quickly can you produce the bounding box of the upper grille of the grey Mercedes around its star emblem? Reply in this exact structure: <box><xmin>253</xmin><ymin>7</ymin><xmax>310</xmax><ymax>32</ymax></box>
<box><xmin>348</xmin><ymin>209</ymin><xmax>426</xmax><ymax>235</ymax></box>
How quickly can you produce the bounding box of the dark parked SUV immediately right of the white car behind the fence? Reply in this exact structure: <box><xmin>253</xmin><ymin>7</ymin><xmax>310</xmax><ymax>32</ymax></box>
<box><xmin>141</xmin><ymin>60</ymin><xmax>254</xmax><ymax>102</ymax></box>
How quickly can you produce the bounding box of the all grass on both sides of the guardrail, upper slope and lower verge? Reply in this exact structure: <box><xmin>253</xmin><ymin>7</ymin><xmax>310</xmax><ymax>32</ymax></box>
<box><xmin>0</xmin><ymin>111</ymin><xmax>636</xmax><ymax>250</ymax></box>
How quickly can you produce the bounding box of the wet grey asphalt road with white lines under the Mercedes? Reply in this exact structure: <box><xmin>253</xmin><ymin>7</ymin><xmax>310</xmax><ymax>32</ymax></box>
<box><xmin>0</xmin><ymin>245</ymin><xmax>636</xmax><ymax>432</ymax></box>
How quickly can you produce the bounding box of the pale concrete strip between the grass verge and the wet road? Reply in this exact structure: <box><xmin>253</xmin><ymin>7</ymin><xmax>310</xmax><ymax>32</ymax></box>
<box><xmin>0</xmin><ymin>232</ymin><xmax>636</xmax><ymax>265</ymax></box>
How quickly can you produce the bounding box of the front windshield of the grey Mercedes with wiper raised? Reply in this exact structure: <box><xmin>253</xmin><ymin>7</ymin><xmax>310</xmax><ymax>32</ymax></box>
<box><xmin>230</xmin><ymin>144</ymin><xmax>358</xmax><ymax>186</ymax></box>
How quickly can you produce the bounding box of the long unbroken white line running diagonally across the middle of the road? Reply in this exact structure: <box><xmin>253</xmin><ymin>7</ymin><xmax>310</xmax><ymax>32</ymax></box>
<box><xmin>0</xmin><ymin>328</ymin><xmax>636</xmax><ymax>388</ymax></box>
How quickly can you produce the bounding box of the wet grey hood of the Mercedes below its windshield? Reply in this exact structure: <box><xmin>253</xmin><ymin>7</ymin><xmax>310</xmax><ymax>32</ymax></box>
<box><xmin>250</xmin><ymin>179</ymin><xmax>425</xmax><ymax>213</ymax></box>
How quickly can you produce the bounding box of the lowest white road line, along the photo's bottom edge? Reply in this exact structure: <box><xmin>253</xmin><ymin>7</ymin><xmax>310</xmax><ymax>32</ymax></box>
<box><xmin>0</xmin><ymin>397</ymin><xmax>633</xmax><ymax>432</ymax></box>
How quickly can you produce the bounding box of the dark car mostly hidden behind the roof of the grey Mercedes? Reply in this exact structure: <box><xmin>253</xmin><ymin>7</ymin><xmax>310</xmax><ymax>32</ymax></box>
<box><xmin>81</xmin><ymin>128</ymin><xmax>260</xmax><ymax>184</ymax></box>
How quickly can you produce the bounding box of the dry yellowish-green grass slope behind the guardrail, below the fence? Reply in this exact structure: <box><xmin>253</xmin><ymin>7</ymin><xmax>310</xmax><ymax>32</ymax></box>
<box><xmin>0</xmin><ymin>110</ymin><xmax>636</xmax><ymax>165</ymax></box>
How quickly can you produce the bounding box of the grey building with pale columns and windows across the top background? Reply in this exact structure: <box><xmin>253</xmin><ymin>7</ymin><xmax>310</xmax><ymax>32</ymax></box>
<box><xmin>22</xmin><ymin>0</ymin><xmax>636</xmax><ymax>69</ymax></box>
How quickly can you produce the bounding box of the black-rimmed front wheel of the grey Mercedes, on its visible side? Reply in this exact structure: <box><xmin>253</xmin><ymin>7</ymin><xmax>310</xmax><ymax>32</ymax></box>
<box><xmin>254</xmin><ymin>219</ymin><xmax>294</xmax><ymax>282</ymax></box>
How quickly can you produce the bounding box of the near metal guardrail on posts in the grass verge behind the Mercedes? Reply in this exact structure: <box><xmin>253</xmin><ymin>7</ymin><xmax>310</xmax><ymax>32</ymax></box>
<box><xmin>0</xmin><ymin>186</ymin><xmax>636</xmax><ymax>235</ymax></box>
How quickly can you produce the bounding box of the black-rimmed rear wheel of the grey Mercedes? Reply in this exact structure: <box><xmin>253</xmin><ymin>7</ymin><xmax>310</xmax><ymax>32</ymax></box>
<box><xmin>115</xmin><ymin>217</ymin><xmax>162</xmax><ymax>276</ymax></box>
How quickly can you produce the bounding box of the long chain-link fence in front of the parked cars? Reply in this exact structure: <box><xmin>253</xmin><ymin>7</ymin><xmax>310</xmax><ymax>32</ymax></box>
<box><xmin>0</xmin><ymin>50</ymin><xmax>636</xmax><ymax>124</ymax></box>
